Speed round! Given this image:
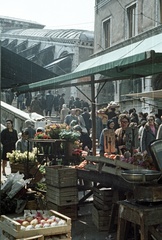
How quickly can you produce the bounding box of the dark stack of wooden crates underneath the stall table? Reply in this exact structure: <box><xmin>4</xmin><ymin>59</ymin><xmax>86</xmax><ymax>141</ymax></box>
<box><xmin>92</xmin><ymin>187</ymin><xmax>113</xmax><ymax>231</ymax></box>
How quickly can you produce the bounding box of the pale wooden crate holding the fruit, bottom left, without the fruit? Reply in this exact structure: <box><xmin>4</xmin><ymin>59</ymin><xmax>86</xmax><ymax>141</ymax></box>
<box><xmin>0</xmin><ymin>210</ymin><xmax>71</xmax><ymax>240</ymax></box>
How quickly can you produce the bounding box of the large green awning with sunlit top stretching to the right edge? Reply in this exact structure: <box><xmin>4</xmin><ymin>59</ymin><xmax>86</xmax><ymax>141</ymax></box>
<box><xmin>16</xmin><ymin>34</ymin><xmax>162</xmax><ymax>92</ymax></box>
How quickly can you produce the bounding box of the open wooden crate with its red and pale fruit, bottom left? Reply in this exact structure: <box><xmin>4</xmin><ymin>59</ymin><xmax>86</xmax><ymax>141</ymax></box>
<box><xmin>0</xmin><ymin>210</ymin><xmax>71</xmax><ymax>240</ymax></box>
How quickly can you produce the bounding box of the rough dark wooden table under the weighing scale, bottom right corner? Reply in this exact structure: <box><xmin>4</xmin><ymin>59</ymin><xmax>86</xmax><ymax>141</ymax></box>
<box><xmin>117</xmin><ymin>201</ymin><xmax>162</xmax><ymax>240</ymax></box>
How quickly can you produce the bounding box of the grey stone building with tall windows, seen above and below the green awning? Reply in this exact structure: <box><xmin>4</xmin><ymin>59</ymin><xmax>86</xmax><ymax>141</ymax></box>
<box><xmin>94</xmin><ymin>0</ymin><xmax>162</xmax><ymax>116</ymax></box>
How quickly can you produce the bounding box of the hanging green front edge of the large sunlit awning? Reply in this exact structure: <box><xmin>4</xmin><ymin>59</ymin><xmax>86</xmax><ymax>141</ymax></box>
<box><xmin>14</xmin><ymin>51</ymin><xmax>155</xmax><ymax>92</ymax></box>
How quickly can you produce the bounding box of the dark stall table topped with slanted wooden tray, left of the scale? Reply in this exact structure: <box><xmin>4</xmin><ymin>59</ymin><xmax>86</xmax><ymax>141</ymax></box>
<box><xmin>77</xmin><ymin>156</ymin><xmax>142</xmax><ymax>194</ymax></box>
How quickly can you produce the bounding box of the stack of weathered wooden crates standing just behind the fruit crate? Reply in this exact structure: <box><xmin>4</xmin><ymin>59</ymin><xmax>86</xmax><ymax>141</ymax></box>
<box><xmin>46</xmin><ymin>166</ymin><xmax>78</xmax><ymax>220</ymax></box>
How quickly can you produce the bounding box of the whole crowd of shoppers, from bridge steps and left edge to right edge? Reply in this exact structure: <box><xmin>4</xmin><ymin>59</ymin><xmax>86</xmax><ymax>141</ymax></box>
<box><xmin>1</xmin><ymin>86</ymin><xmax>162</xmax><ymax>174</ymax></box>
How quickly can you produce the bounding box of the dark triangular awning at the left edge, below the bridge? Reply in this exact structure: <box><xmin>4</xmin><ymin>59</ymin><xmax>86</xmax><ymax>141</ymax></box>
<box><xmin>0</xmin><ymin>46</ymin><xmax>57</xmax><ymax>89</ymax></box>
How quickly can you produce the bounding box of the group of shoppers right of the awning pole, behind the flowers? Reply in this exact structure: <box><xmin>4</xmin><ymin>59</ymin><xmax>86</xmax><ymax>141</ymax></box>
<box><xmin>99</xmin><ymin>109</ymin><xmax>162</xmax><ymax>156</ymax></box>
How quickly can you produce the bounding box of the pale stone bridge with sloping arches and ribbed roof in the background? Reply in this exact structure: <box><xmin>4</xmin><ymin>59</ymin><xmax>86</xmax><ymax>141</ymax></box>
<box><xmin>0</xmin><ymin>17</ymin><xmax>94</xmax><ymax>101</ymax></box>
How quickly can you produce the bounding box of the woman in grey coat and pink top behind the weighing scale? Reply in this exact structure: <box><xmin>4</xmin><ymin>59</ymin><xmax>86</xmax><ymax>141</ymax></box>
<box><xmin>140</xmin><ymin>115</ymin><xmax>158</xmax><ymax>155</ymax></box>
